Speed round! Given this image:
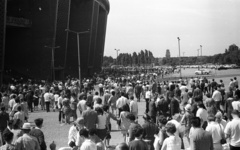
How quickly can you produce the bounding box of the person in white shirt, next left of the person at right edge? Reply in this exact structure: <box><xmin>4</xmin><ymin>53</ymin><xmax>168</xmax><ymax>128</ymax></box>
<box><xmin>206</xmin><ymin>115</ymin><xmax>225</xmax><ymax>150</ymax></box>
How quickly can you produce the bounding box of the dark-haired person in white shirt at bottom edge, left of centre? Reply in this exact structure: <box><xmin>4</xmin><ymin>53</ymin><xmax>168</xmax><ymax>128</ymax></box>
<box><xmin>80</xmin><ymin>129</ymin><xmax>97</xmax><ymax>150</ymax></box>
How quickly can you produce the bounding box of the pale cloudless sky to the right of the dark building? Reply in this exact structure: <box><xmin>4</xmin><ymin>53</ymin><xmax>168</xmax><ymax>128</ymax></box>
<box><xmin>104</xmin><ymin>0</ymin><xmax>240</xmax><ymax>58</ymax></box>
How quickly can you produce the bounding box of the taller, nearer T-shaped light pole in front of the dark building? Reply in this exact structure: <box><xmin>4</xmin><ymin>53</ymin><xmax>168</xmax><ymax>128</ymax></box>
<box><xmin>65</xmin><ymin>29</ymin><xmax>89</xmax><ymax>90</ymax></box>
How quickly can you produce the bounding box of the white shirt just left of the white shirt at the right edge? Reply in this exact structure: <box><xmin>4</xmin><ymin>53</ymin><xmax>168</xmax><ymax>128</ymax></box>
<box><xmin>206</xmin><ymin>121</ymin><xmax>224</xmax><ymax>144</ymax></box>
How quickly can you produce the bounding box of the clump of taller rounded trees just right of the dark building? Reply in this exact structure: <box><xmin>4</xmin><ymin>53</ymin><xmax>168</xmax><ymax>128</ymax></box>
<box><xmin>103</xmin><ymin>50</ymin><xmax>155</xmax><ymax>67</ymax></box>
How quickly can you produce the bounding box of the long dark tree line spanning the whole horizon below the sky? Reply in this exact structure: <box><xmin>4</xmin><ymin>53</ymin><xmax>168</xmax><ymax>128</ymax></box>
<box><xmin>103</xmin><ymin>44</ymin><xmax>240</xmax><ymax>67</ymax></box>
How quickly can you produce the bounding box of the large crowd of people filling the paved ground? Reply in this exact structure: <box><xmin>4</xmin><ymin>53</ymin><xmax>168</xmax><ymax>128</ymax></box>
<box><xmin>0</xmin><ymin>75</ymin><xmax>240</xmax><ymax>150</ymax></box>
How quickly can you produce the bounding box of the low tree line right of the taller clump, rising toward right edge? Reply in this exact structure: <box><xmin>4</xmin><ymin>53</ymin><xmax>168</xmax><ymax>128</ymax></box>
<box><xmin>161</xmin><ymin>44</ymin><xmax>240</xmax><ymax>66</ymax></box>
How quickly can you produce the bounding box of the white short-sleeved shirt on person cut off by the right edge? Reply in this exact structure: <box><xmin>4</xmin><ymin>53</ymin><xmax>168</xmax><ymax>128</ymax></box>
<box><xmin>224</xmin><ymin>118</ymin><xmax>240</xmax><ymax>147</ymax></box>
